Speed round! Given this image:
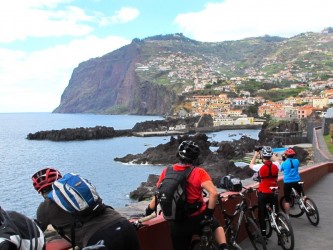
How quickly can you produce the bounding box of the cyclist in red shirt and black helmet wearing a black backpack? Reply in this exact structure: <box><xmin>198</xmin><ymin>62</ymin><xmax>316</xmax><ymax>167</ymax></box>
<box><xmin>146</xmin><ymin>140</ymin><xmax>227</xmax><ymax>250</ymax></box>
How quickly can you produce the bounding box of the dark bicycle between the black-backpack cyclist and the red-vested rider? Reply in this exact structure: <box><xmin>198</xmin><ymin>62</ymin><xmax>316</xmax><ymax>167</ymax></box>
<box><xmin>218</xmin><ymin>188</ymin><xmax>267</xmax><ymax>250</ymax></box>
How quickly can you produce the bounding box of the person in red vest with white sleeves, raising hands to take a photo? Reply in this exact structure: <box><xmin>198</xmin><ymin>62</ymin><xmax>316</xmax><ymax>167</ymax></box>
<box><xmin>250</xmin><ymin>146</ymin><xmax>280</xmax><ymax>240</ymax></box>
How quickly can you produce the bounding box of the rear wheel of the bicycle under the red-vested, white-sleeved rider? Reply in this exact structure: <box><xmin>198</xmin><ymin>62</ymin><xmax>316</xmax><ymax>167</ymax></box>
<box><xmin>276</xmin><ymin>212</ymin><xmax>295</xmax><ymax>250</ymax></box>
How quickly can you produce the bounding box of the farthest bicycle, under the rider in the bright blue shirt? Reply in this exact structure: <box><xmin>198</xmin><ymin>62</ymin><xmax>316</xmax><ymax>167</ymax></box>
<box><xmin>280</xmin><ymin>181</ymin><xmax>319</xmax><ymax>226</ymax></box>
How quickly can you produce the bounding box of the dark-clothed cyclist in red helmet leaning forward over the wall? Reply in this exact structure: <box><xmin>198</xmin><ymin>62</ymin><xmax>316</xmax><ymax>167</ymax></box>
<box><xmin>32</xmin><ymin>167</ymin><xmax>140</xmax><ymax>250</ymax></box>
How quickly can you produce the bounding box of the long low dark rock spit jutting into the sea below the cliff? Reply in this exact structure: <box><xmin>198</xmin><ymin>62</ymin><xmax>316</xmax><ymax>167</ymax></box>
<box><xmin>26</xmin><ymin>115</ymin><xmax>261</xmax><ymax>141</ymax></box>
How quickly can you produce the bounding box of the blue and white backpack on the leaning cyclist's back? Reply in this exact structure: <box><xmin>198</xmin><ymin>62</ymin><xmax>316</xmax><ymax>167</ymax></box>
<box><xmin>48</xmin><ymin>173</ymin><xmax>105</xmax><ymax>216</ymax></box>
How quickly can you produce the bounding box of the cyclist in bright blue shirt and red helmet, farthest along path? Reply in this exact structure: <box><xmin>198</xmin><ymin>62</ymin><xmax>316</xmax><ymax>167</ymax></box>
<box><xmin>280</xmin><ymin>148</ymin><xmax>304</xmax><ymax>216</ymax></box>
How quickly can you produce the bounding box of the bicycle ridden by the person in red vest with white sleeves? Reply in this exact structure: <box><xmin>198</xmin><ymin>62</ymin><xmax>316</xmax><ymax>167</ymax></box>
<box><xmin>252</xmin><ymin>187</ymin><xmax>295</xmax><ymax>250</ymax></box>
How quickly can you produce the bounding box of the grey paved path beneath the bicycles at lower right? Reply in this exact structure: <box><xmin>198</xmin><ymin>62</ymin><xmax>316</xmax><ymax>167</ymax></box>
<box><xmin>241</xmin><ymin>174</ymin><xmax>333</xmax><ymax>250</ymax></box>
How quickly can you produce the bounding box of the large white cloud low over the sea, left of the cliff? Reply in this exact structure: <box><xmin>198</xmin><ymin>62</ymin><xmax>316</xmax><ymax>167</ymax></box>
<box><xmin>0</xmin><ymin>36</ymin><xmax>130</xmax><ymax>112</ymax></box>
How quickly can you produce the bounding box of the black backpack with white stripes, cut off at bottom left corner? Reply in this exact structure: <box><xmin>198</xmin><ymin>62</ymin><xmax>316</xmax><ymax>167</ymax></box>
<box><xmin>0</xmin><ymin>207</ymin><xmax>45</xmax><ymax>250</ymax></box>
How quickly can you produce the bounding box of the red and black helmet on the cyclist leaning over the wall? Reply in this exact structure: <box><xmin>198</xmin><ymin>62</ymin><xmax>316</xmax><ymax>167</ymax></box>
<box><xmin>31</xmin><ymin>168</ymin><xmax>62</xmax><ymax>193</ymax></box>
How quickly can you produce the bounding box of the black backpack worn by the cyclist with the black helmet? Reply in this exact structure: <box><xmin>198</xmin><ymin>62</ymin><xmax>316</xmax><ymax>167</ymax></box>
<box><xmin>156</xmin><ymin>166</ymin><xmax>194</xmax><ymax>221</ymax></box>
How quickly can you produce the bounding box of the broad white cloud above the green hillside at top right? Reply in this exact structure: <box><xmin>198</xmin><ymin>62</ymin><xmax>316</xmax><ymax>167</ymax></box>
<box><xmin>175</xmin><ymin>0</ymin><xmax>333</xmax><ymax>42</ymax></box>
